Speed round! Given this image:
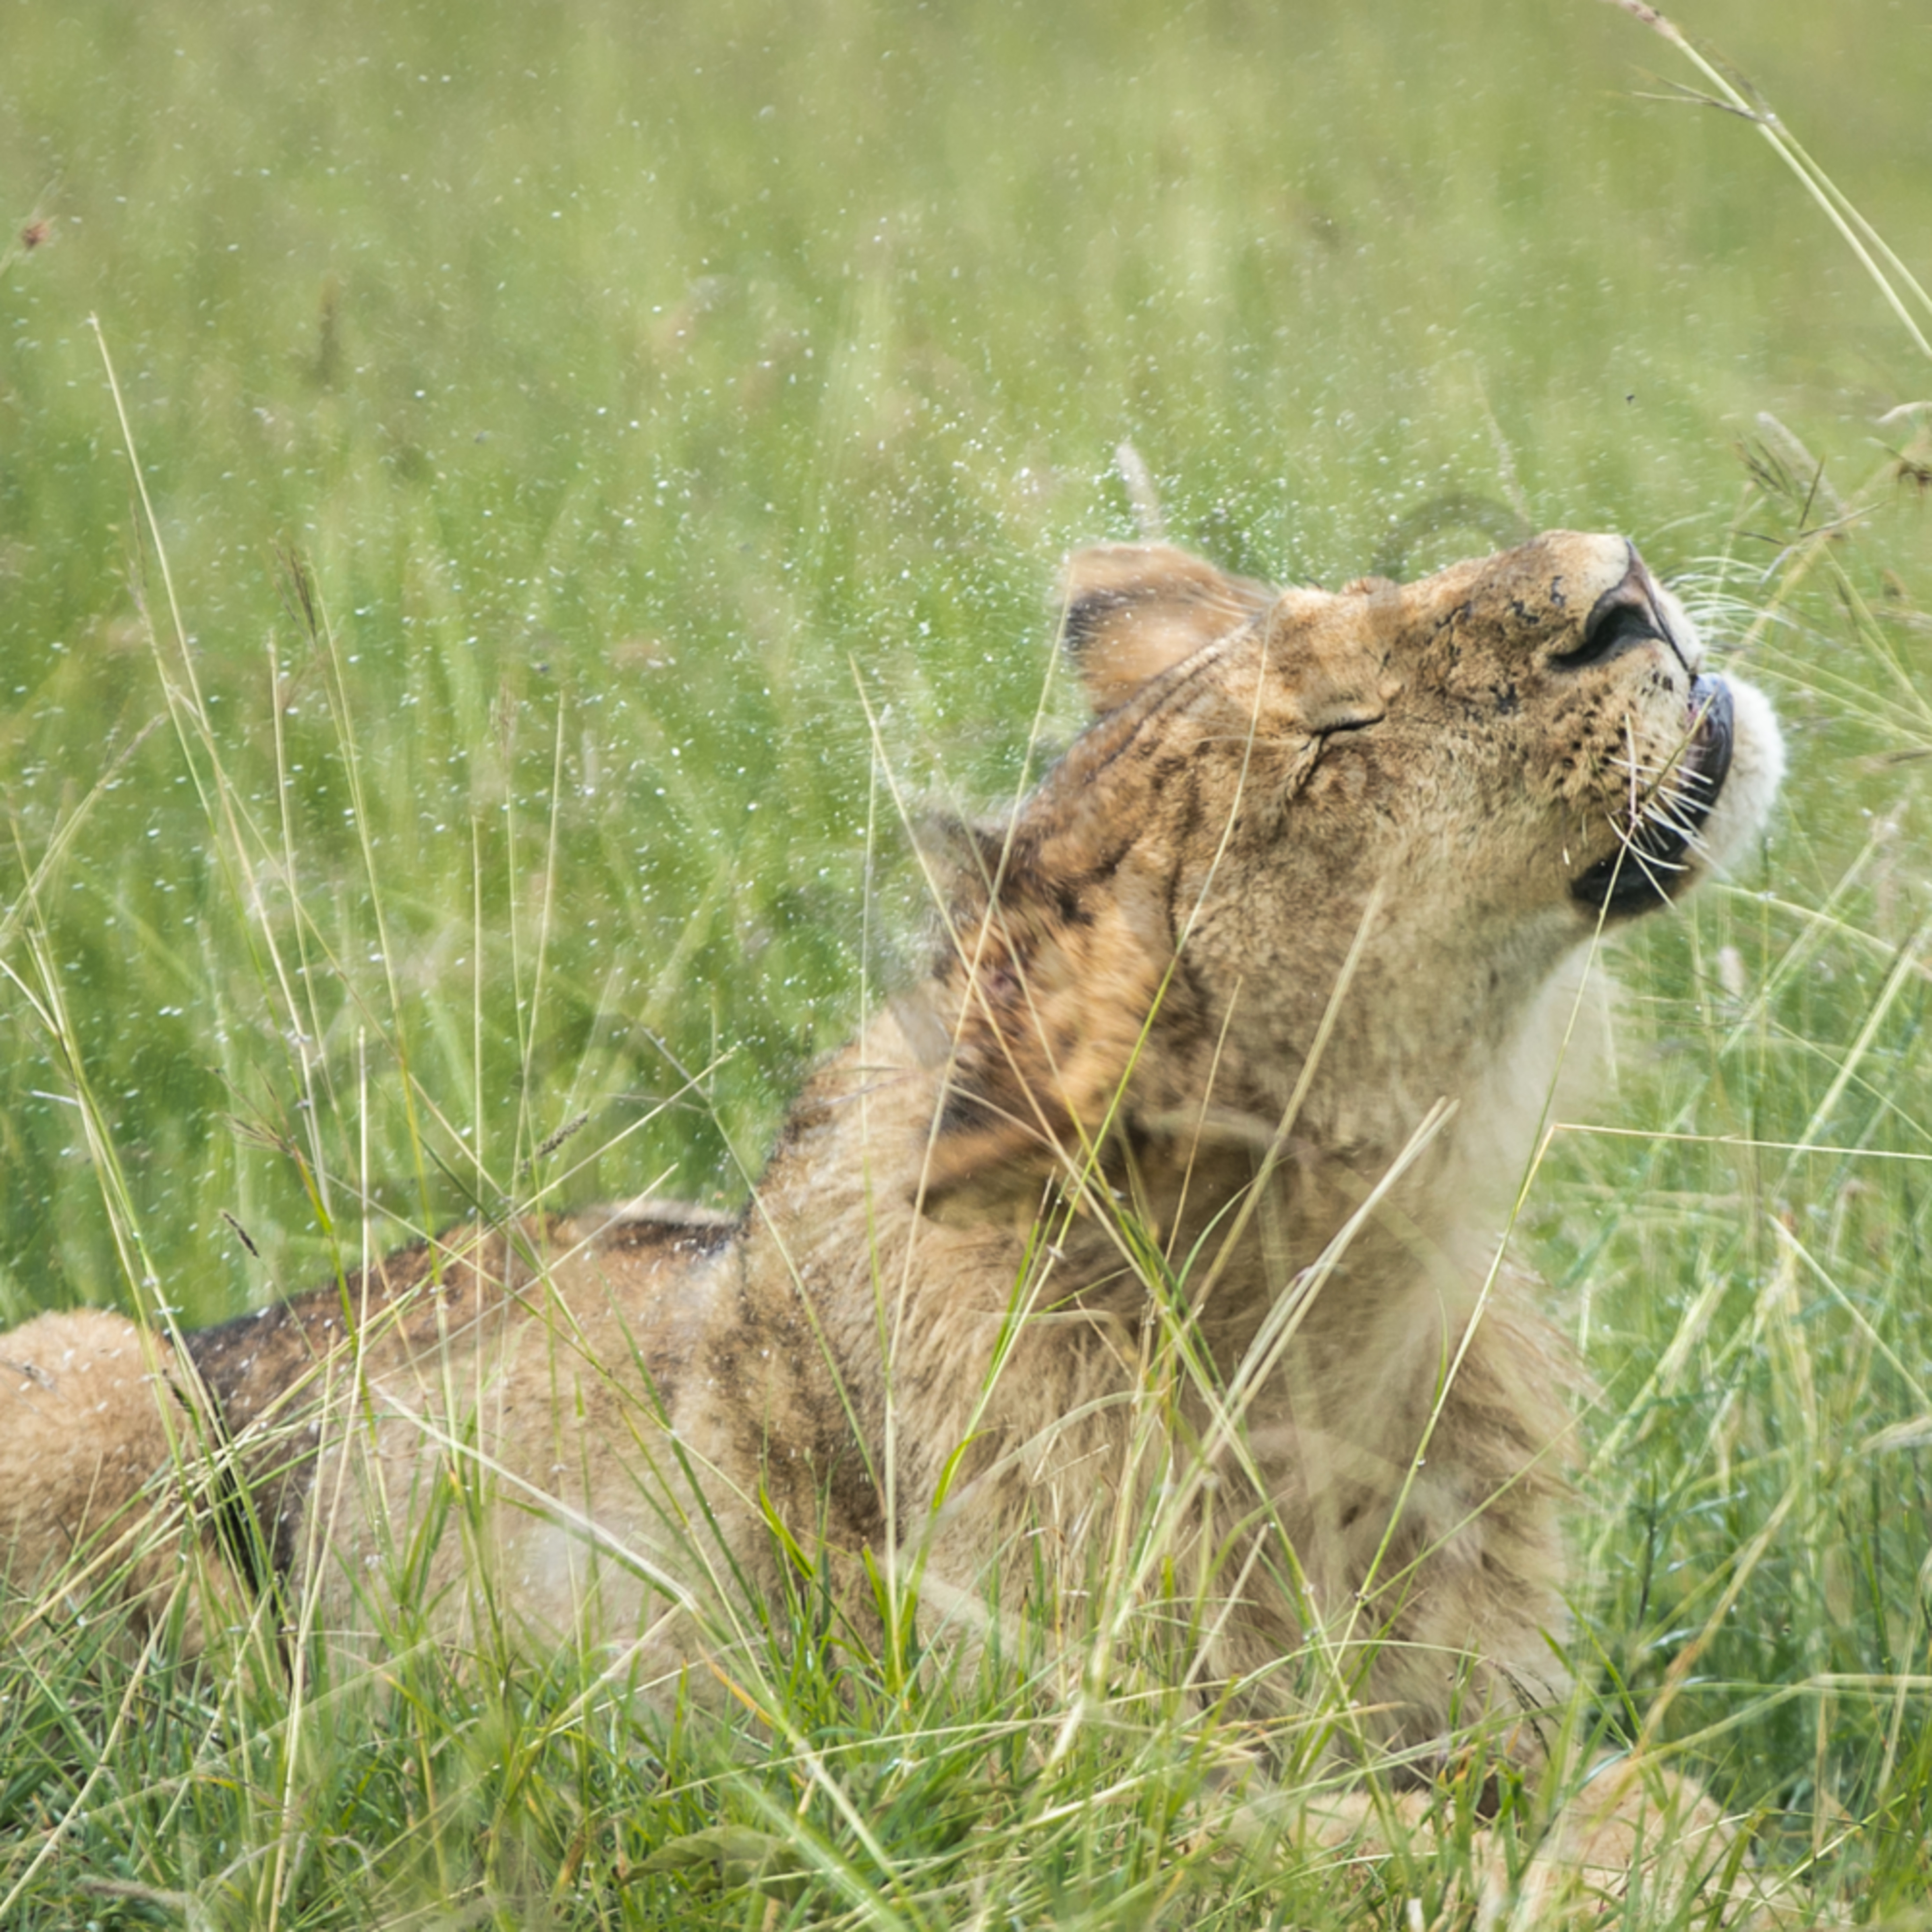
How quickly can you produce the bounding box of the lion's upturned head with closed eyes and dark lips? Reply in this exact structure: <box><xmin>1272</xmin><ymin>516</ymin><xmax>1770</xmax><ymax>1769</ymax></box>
<box><xmin>916</xmin><ymin>531</ymin><xmax>1783</xmax><ymax>1182</ymax></box>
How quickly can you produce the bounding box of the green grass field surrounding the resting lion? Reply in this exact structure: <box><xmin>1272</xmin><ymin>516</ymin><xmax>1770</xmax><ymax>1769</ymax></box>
<box><xmin>0</xmin><ymin>0</ymin><xmax>1932</xmax><ymax>1932</ymax></box>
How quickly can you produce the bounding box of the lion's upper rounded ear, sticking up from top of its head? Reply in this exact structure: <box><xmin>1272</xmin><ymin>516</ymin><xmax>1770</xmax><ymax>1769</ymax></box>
<box><xmin>1061</xmin><ymin>543</ymin><xmax>1275</xmax><ymax>717</ymax></box>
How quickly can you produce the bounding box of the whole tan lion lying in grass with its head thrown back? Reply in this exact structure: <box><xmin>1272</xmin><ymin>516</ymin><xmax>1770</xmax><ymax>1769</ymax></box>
<box><xmin>0</xmin><ymin>531</ymin><xmax>1783</xmax><ymax>1770</ymax></box>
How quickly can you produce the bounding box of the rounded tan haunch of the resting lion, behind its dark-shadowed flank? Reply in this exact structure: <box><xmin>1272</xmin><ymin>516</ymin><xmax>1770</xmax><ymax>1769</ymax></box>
<box><xmin>0</xmin><ymin>1308</ymin><xmax>245</xmax><ymax>1652</ymax></box>
